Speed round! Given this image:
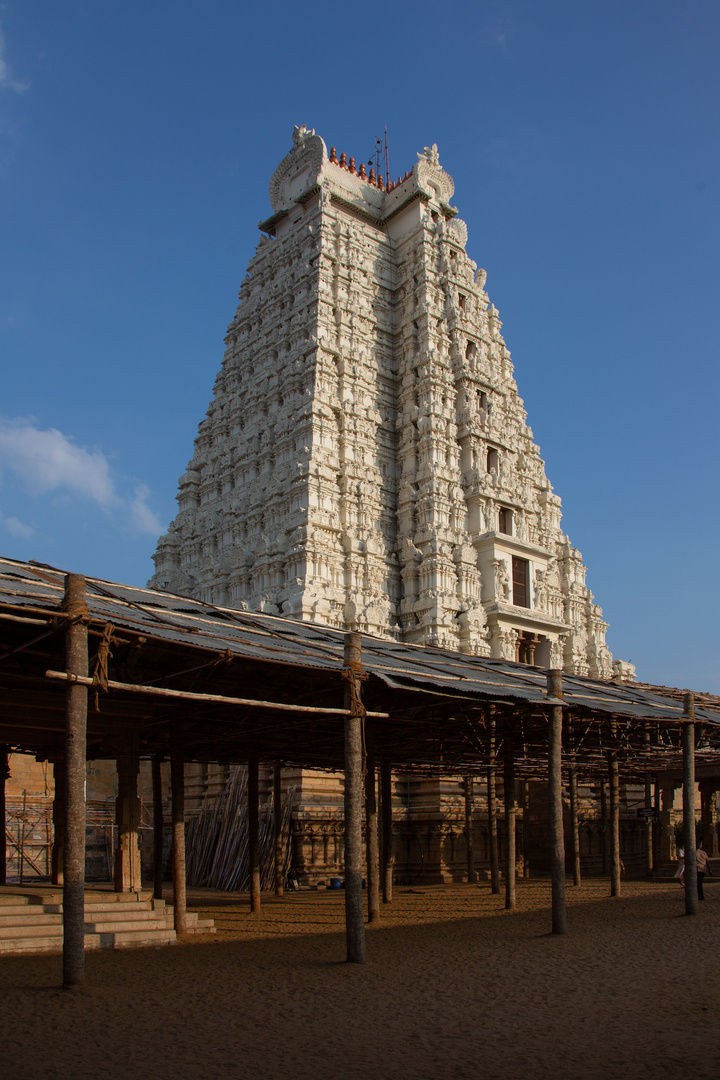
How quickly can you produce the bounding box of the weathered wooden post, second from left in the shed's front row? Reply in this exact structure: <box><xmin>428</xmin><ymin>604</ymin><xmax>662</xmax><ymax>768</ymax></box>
<box><xmin>343</xmin><ymin>633</ymin><xmax>365</xmax><ymax>963</ymax></box>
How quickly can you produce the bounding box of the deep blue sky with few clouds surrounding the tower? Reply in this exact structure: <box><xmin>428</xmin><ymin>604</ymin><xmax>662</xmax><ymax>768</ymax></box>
<box><xmin>0</xmin><ymin>0</ymin><xmax>720</xmax><ymax>693</ymax></box>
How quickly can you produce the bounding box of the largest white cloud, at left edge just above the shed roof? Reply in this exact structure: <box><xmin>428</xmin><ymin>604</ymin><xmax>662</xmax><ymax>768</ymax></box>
<box><xmin>0</xmin><ymin>420</ymin><xmax>120</xmax><ymax>509</ymax></box>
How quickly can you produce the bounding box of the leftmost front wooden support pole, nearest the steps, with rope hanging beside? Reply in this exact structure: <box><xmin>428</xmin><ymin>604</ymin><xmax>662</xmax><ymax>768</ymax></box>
<box><xmin>63</xmin><ymin>573</ymin><xmax>89</xmax><ymax>989</ymax></box>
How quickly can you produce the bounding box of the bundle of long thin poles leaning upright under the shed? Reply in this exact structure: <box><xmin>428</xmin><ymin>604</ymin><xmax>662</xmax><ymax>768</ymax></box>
<box><xmin>186</xmin><ymin>766</ymin><xmax>295</xmax><ymax>892</ymax></box>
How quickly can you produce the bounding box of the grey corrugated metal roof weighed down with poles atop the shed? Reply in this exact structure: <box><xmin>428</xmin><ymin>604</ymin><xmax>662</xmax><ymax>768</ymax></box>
<box><xmin>0</xmin><ymin>559</ymin><xmax>720</xmax><ymax>725</ymax></box>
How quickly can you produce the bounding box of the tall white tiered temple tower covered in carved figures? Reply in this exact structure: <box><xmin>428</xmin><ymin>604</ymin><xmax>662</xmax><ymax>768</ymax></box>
<box><xmin>150</xmin><ymin>127</ymin><xmax>613</xmax><ymax>678</ymax></box>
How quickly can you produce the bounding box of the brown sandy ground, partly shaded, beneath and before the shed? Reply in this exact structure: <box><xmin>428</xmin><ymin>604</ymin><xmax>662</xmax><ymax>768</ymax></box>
<box><xmin>0</xmin><ymin>879</ymin><xmax>720</xmax><ymax>1080</ymax></box>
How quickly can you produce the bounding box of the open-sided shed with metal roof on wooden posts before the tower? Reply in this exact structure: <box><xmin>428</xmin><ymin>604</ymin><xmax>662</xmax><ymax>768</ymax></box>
<box><xmin>0</xmin><ymin>559</ymin><xmax>720</xmax><ymax>984</ymax></box>
